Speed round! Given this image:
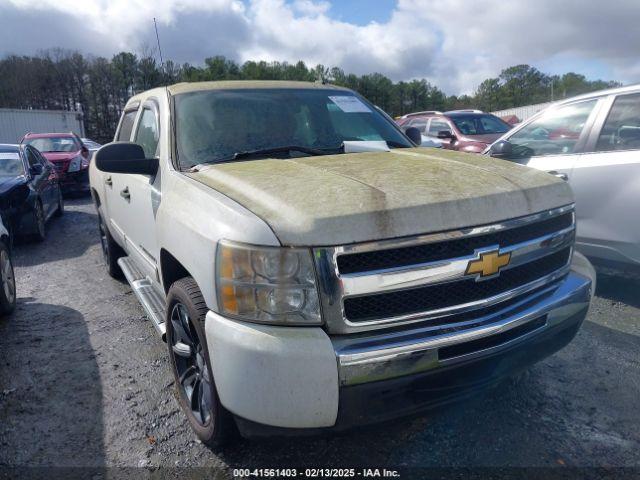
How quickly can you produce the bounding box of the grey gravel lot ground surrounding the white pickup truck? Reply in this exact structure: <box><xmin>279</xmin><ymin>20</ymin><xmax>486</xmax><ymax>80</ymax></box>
<box><xmin>0</xmin><ymin>199</ymin><xmax>640</xmax><ymax>476</ymax></box>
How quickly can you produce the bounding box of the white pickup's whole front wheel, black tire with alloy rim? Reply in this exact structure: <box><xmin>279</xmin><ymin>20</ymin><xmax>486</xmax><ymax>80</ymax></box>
<box><xmin>165</xmin><ymin>277</ymin><xmax>235</xmax><ymax>449</ymax></box>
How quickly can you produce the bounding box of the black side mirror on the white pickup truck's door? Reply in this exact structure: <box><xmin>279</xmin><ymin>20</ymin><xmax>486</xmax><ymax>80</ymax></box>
<box><xmin>94</xmin><ymin>142</ymin><xmax>158</xmax><ymax>175</ymax></box>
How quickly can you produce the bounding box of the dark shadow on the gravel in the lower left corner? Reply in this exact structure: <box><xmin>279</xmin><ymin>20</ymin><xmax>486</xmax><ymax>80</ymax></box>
<box><xmin>0</xmin><ymin>304</ymin><xmax>105</xmax><ymax>467</ymax></box>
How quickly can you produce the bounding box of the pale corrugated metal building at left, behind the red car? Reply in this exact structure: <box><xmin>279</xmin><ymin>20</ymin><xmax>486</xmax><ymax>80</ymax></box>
<box><xmin>0</xmin><ymin>108</ymin><xmax>85</xmax><ymax>143</ymax></box>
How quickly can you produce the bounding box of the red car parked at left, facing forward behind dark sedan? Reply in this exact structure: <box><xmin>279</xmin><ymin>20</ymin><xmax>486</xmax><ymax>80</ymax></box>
<box><xmin>22</xmin><ymin>133</ymin><xmax>91</xmax><ymax>193</ymax></box>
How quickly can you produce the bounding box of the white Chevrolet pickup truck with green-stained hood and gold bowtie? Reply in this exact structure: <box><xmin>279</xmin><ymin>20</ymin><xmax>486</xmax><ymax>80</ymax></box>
<box><xmin>90</xmin><ymin>82</ymin><xmax>595</xmax><ymax>447</ymax></box>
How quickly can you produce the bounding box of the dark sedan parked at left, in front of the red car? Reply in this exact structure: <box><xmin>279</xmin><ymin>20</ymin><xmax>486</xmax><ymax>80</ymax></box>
<box><xmin>0</xmin><ymin>144</ymin><xmax>64</xmax><ymax>241</ymax></box>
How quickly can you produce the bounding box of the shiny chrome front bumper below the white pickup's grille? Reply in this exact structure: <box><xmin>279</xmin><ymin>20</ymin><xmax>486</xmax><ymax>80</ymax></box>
<box><xmin>332</xmin><ymin>254</ymin><xmax>595</xmax><ymax>387</ymax></box>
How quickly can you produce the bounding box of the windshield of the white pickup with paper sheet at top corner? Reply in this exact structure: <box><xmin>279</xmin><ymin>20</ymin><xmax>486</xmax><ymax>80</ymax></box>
<box><xmin>175</xmin><ymin>89</ymin><xmax>412</xmax><ymax>168</ymax></box>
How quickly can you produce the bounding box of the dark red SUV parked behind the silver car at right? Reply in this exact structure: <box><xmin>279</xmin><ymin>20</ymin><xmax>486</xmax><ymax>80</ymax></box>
<box><xmin>397</xmin><ymin>110</ymin><xmax>511</xmax><ymax>153</ymax></box>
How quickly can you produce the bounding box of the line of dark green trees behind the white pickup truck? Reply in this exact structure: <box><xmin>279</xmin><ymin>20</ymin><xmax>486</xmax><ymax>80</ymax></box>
<box><xmin>0</xmin><ymin>49</ymin><xmax>619</xmax><ymax>142</ymax></box>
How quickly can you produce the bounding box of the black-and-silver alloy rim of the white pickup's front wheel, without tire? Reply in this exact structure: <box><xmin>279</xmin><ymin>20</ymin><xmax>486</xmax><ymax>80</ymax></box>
<box><xmin>169</xmin><ymin>303</ymin><xmax>214</xmax><ymax>426</ymax></box>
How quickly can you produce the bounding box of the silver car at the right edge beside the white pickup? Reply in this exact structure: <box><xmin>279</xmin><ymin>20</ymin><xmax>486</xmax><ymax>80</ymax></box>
<box><xmin>489</xmin><ymin>85</ymin><xmax>640</xmax><ymax>268</ymax></box>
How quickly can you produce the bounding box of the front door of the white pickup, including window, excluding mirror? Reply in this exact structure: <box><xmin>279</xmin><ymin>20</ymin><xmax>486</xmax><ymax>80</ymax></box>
<box><xmin>118</xmin><ymin>100</ymin><xmax>161</xmax><ymax>285</ymax></box>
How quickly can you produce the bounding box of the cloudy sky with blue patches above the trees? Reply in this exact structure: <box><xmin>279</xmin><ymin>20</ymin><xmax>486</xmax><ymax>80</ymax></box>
<box><xmin>0</xmin><ymin>0</ymin><xmax>640</xmax><ymax>94</ymax></box>
